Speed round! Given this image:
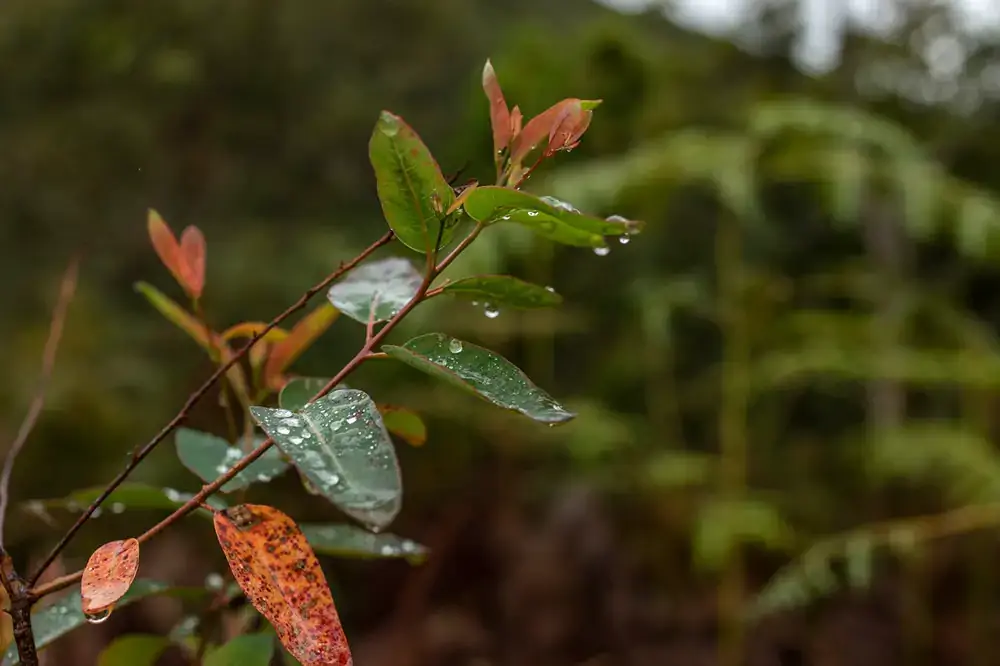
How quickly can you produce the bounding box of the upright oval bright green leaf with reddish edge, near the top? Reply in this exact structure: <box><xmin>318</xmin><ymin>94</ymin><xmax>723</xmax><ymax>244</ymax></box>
<box><xmin>368</xmin><ymin>111</ymin><xmax>455</xmax><ymax>254</ymax></box>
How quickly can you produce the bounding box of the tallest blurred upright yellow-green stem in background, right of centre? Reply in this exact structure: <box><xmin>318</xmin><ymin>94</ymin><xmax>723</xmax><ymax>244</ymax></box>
<box><xmin>715</xmin><ymin>213</ymin><xmax>749</xmax><ymax>666</ymax></box>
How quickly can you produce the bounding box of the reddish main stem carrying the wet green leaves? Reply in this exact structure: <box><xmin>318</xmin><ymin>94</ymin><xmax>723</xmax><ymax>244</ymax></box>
<box><xmin>32</xmin><ymin>223</ymin><xmax>485</xmax><ymax>600</ymax></box>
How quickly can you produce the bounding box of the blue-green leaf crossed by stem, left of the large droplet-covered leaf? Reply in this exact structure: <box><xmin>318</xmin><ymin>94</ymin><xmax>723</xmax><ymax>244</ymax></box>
<box><xmin>175</xmin><ymin>428</ymin><xmax>288</xmax><ymax>493</ymax></box>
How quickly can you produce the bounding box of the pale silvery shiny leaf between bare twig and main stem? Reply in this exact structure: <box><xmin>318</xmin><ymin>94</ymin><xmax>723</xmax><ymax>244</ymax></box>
<box><xmin>327</xmin><ymin>257</ymin><xmax>423</xmax><ymax>324</ymax></box>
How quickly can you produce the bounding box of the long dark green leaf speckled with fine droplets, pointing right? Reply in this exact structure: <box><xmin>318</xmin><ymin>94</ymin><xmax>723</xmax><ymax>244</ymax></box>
<box><xmin>382</xmin><ymin>333</ymin><xmax>576</xmax><ymax>423</ymax></box>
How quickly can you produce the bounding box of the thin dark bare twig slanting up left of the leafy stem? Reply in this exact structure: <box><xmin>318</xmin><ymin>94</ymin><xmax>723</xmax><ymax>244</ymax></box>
<box><xmin>29</xmin><ymin>231</ymin><xmax>394</xmax><ymax>586</ymax></box>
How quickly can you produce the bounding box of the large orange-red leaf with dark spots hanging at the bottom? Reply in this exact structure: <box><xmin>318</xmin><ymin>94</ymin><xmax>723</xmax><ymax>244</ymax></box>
<box><xmin>215</xmin><ymin>504</ymin><xmax>354</xmax><ymax>666</ymax></box>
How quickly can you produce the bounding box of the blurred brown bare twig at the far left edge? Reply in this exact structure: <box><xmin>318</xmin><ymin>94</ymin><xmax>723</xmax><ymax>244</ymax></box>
<box><xmin>0</xmin><ymin>257</ymin><xmax>80</xmax><ymax>551</ymax></box>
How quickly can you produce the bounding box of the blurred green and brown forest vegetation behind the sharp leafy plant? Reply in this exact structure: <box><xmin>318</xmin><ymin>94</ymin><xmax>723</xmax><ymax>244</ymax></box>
<box><xmin>0</xmin><ymin>0</ymin><xmax>1000</xmax><ymax>666</ymax></box>
